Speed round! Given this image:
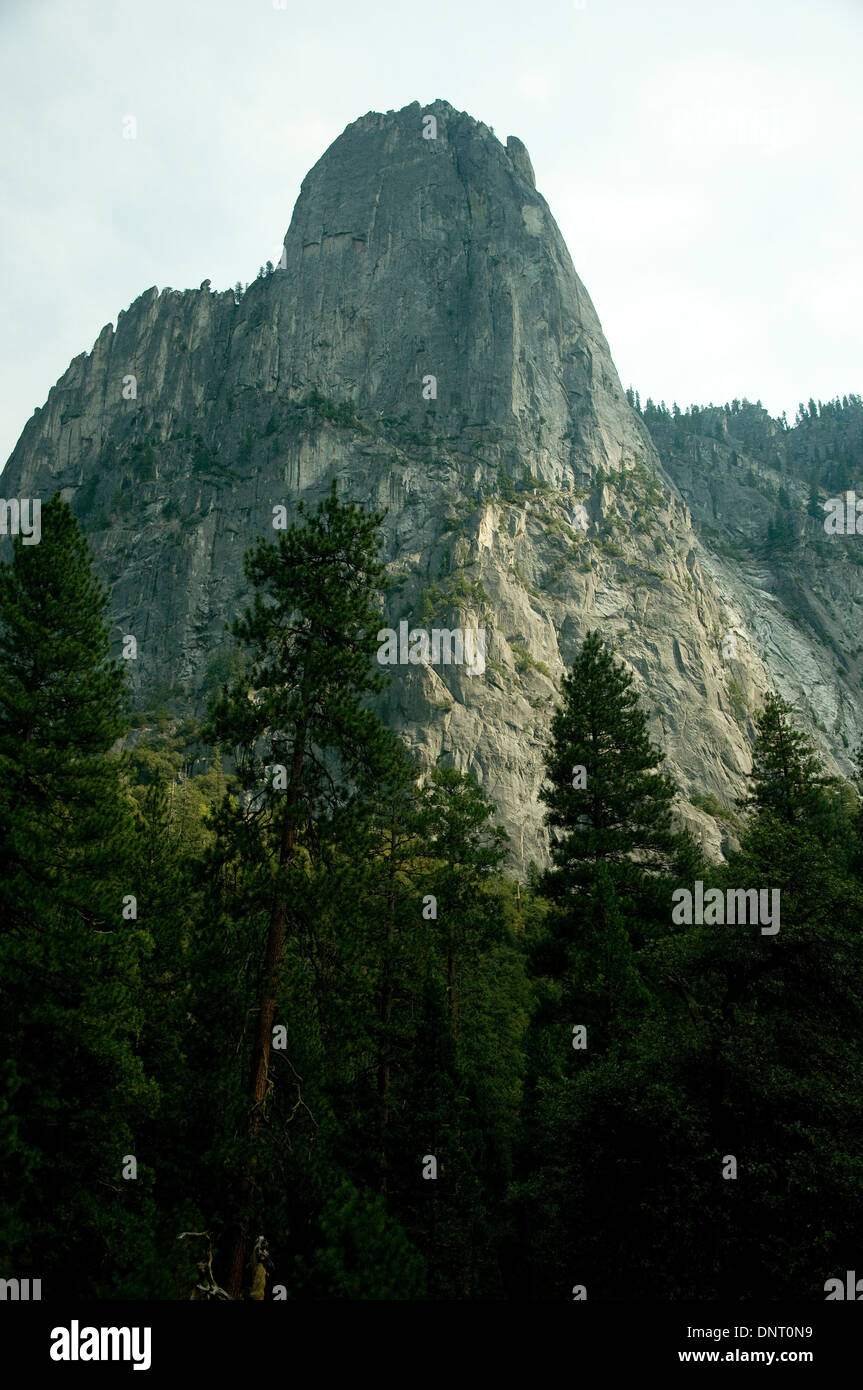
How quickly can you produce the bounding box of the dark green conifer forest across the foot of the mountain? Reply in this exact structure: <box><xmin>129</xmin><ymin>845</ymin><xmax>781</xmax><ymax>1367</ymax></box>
<box><xmin>0</xmin><ymin>500</ymin><xmax>863</xmax><ymax>1301</ymax></box>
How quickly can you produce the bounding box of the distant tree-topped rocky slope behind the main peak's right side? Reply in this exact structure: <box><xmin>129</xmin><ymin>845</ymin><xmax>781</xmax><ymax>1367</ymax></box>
<box><xmin>645</xmin><ymin>396</ymin><xmax>863</xmax><ymax>774</ymax></box>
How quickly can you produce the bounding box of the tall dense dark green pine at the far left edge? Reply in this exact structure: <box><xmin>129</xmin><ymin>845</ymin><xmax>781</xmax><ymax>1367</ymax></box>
<box><xmin>0</xmin><ymin>498</ymin><xmax>156</xmax><ymax>1294</ymax></box>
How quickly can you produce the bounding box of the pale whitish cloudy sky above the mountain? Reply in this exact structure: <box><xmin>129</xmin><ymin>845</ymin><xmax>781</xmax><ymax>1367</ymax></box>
<box><xmin>0</xmin><ymin>0</ymin><xmax>863</xmax><ymax>461</ymax></box>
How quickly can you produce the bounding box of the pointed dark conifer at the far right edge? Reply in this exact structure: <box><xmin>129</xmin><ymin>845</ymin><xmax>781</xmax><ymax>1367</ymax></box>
<box><xmin>636</xmin><ymin>696</ymin><xmax>863</xmax><ymax>1298</ymax></box>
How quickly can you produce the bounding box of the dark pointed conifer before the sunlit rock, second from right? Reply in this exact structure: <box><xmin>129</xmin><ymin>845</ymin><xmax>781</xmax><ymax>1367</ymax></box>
<box><xmin>516</xmin><ymin>632</ymin><xmax>693</xmax><ymax>1297</ymax></box>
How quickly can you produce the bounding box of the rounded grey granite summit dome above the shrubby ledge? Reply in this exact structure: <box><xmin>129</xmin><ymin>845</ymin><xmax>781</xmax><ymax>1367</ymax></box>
<box><xmin>272</xmin><ymin>100</ymin><xmax>603</xmax><ymax>439</ymax></box>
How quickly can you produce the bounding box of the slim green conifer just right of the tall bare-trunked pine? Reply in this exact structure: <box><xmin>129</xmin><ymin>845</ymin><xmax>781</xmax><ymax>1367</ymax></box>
<box><xmin>414</xmin><ymin>767</ymin><xmax>527</xmax><ymax>1298</ymax></box>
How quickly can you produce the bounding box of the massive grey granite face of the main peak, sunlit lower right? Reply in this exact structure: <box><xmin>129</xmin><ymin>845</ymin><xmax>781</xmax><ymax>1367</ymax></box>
<box><xmin>0</xmin><ymin>101</ymin><xmax>859</xmax><ymax>870</ymax></box>
